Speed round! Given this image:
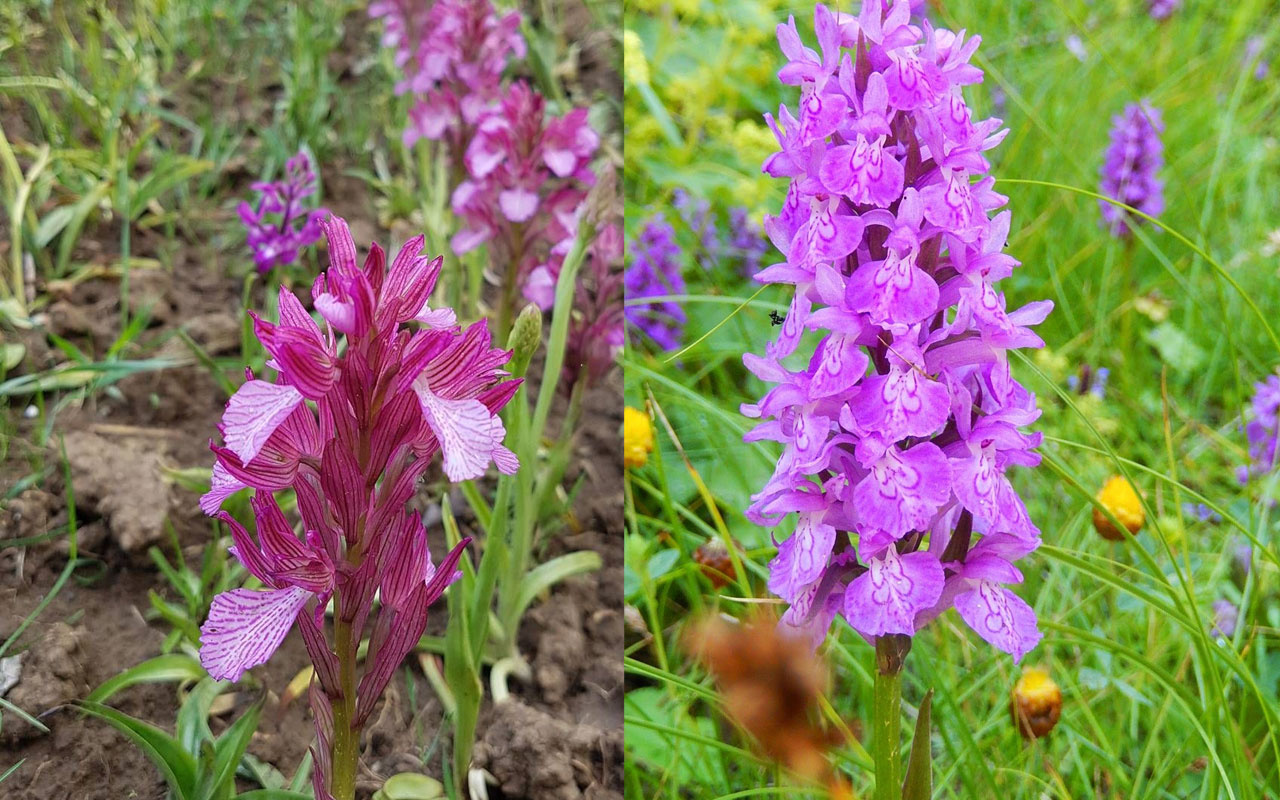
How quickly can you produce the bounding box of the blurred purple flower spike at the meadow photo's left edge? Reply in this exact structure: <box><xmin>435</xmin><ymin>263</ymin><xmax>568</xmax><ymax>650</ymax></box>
<box><xmin>625</xmin><ymin>214</ymin><xmax>689</xmax><ymax>351</ymax></box>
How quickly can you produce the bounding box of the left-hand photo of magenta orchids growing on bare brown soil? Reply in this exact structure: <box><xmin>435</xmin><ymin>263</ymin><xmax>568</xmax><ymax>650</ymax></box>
<box><xmin>0</xmin><ymin>0</ymin><xmax>623</xmax><ymax>800</ymax></box>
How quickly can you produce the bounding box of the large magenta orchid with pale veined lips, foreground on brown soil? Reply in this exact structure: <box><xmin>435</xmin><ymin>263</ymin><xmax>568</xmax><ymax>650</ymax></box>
<box><xmin>200</xmin><ymin>212</ymin><xmax>520</xmax><ymax>799</ymax></box>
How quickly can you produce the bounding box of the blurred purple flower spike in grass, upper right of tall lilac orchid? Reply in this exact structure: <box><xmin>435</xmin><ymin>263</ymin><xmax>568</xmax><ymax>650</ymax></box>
<box><xmin>1098</xmin><ymin>100</ymin><xmax>1165</xmax><ymax>237</ymax></box>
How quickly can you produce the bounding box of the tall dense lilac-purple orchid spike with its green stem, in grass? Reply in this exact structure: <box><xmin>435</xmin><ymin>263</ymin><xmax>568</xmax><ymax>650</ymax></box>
<box><xmin>742</xmin><ymin>0</ymin><xmax>1052</xmax><ymax>797</ymax></box>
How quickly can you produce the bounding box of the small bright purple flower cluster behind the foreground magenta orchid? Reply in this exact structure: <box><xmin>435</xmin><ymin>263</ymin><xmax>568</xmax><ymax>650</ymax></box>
<box><xmin>238</xmin><ymin>150</ymin><xmax>329</xmax><ymax>274</ymax></box>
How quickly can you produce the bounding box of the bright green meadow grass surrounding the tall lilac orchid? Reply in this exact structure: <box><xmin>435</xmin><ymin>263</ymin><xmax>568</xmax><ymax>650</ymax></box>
<box><xmin>625</xmin><ymin>0</ymin><xmax>1280</xmax><ymax>799</ymax></box>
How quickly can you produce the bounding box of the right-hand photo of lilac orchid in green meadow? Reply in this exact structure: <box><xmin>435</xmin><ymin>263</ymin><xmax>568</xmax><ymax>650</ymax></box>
<box><xmin>623</xmin><ymin>0</ymin><xmax>1280</xmax><ymax>800</ymax></box>
